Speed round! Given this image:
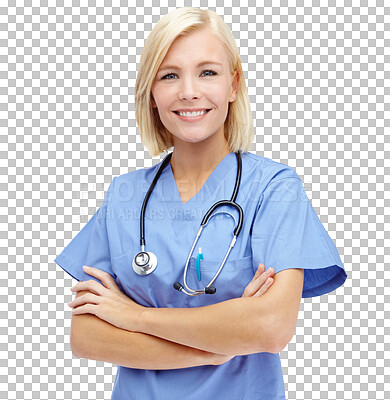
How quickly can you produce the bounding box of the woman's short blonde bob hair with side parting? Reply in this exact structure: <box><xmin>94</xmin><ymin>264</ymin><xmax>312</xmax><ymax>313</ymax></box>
<box><xmin>135</xmin><ymin>7</ymin><xmax>254</xmax><ymax>157</ymax></box>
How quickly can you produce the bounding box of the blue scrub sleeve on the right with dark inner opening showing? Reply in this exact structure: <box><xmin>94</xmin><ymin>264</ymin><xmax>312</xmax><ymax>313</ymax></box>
<box><xmin>251</xmin><ymin>171</ymin><xmax>347</xmax><ymax>297</ymax></box>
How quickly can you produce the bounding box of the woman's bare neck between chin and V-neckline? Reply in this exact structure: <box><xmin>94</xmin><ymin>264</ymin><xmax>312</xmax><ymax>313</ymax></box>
<box><xmin>171</xmin><ymin>138</ymin><xmax>231</xmax><ymax>182</ymax></box>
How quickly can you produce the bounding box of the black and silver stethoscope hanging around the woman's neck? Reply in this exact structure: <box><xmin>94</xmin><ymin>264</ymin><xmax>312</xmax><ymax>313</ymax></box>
<box><xmin>133</xmin><ymin>152</ymin><xmax>244</xmax><ymax>296</ymax></box>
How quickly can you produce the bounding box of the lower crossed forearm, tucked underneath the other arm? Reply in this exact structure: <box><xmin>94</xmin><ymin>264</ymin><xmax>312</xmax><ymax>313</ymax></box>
<box><xmin>71</xmin><ymin>314</ymin><xmax>222</xmax><ymax>370</ymax></box>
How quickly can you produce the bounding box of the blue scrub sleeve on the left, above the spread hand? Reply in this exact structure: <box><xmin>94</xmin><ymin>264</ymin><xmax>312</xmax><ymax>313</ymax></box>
<box><xmin>54</xmin><ymin>178</ymin><xmax>115</xmax><ymax>283</ymax></box>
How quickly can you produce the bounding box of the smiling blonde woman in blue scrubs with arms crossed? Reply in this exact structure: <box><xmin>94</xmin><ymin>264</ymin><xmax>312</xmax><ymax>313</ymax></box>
<box><xmin>55</xmin><ymin>8</ymin><xmax>346</xmax><ymax>400</ymax></box>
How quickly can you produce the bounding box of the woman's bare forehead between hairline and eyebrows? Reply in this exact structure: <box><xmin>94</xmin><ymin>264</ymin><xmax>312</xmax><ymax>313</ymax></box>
<box><xmin>160</xmin><ymin>28</ymin><xmax>229</xmax><ymax>68</ymax></box>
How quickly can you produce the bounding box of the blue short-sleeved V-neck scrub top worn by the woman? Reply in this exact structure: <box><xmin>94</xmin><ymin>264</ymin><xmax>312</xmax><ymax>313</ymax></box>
<box><xmin>55</xmin><ymin>153</ymin><xmax>347</xmax><ymax>400</ymax></box>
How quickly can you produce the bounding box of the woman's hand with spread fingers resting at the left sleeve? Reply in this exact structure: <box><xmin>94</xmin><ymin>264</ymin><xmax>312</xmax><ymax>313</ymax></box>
<box><xmin>68</xmin><ymin>266</ymin><xmax>144</xmax><ymax>332</ymax></box>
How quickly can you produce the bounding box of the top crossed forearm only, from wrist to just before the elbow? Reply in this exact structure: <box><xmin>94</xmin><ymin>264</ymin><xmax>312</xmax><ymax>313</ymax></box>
<box><xmin>137</xmin><ymin>296</ymin><xmax>279</xmax><ymax>355</ymax></box>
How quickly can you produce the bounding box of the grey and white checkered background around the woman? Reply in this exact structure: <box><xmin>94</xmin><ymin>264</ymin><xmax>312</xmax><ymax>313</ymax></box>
<box><xmin>0</xmin><ymin>0</ymin><xmax>390</xmax><ymax>400</ymax></box>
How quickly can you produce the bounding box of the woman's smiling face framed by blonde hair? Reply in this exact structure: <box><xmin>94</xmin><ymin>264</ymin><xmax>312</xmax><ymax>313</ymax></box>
<box><xmin>152</xmin><ymin>29</ymin><xmax>238</xmax><ymax>144</ymax></box>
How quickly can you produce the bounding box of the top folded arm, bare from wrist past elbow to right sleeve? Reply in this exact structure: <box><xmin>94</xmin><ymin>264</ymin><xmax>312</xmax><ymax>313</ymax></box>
<box><xmin>136</xmin><ymin>269</ymin><xmax>304</xmax><ymax>355</ymax></box>
